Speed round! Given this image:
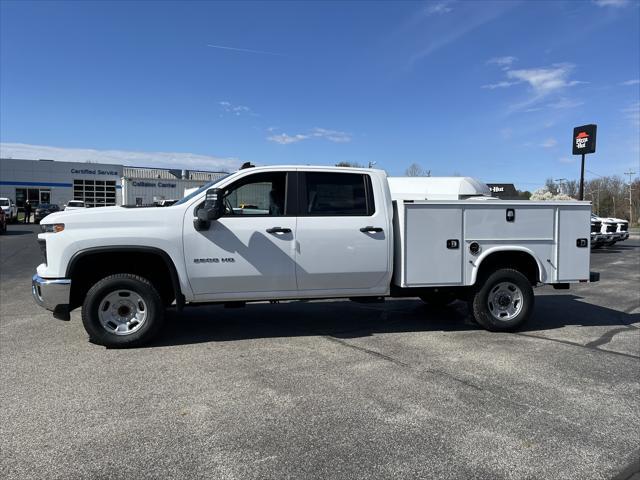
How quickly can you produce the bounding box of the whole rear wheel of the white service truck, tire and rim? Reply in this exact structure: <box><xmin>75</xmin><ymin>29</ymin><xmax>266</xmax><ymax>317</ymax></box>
<box><xmin>471</xmin><ymin>268</ymin><xmax>535</xmax><ymax>332</ymax></box>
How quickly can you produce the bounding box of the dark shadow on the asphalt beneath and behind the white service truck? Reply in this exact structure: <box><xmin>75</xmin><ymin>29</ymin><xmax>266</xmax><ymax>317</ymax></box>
<box><xmin>149</xmin><ymin>295</ymin><xmax>640</xmax><ymax>347</ymax></box>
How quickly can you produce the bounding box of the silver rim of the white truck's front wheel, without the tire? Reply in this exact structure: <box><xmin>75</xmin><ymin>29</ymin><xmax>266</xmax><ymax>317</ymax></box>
<box><xmin>98</xmin><ymin>289</ymin><xmax>148</xmax><ymax>335</ymax></box>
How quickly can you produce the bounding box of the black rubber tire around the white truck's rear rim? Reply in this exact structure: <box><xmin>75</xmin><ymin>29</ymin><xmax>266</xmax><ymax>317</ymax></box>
<box><xmin>471</xmin><ymin>268</ymin><xmax>535</xmax><ymax>332</ymax></box>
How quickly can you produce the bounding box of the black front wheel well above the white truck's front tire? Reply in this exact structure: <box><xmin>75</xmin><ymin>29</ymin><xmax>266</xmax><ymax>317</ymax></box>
<box><xmin>67</xmin><ymin>250</ymin><xmax>180</xmax><ymax>309</ymax></box>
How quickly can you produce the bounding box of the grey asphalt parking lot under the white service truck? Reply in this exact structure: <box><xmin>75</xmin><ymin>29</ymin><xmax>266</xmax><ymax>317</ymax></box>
<box><xmin>0</xmin><ymin>225</ymin><xmax>640</xmax><ymax>480</ymax></box>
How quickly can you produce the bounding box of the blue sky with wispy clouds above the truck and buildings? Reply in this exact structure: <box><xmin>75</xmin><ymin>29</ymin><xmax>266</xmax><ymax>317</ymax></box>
<box><xmin>0</xmin><ymin>0</ymin><xmax>640</xmax><ymax>189</ymax></box>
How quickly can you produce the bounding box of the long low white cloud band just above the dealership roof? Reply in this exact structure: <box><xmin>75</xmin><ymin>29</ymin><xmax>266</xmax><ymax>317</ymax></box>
<box><xmin>0</xmin><ymin>143</ymin><xmax>241</xmax><ymax>171</ymax></box>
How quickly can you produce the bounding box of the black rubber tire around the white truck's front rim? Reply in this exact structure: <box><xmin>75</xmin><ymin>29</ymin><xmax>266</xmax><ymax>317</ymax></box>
<box><xmin>82</xmin><ymin>273</ymin><xmax>165</xmax><ymax>347</ymax></box>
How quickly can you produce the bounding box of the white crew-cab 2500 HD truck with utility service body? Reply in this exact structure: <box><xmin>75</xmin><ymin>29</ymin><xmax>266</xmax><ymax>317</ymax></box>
<box><xmin>32</xmin><ymin>166</ymin><xmax>597</xmax><ymax>346</ymax></box>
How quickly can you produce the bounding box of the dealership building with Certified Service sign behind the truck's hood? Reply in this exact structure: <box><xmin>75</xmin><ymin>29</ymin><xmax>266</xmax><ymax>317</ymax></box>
<box><xmin>0</xmin><ymin>158</ymin><xmax>226</xmax><ymax>208</ymax></box>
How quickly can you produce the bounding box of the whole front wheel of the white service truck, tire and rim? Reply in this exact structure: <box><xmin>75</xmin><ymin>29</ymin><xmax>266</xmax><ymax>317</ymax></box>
<box><xmin>82</xmin><ymin>273</ymin><xmax>164</xmax><ymax>347</ymax></box>
